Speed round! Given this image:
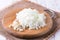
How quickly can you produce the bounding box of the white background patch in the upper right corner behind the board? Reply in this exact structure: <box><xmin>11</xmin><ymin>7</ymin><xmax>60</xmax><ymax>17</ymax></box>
<box><xmin>30</xmin><ymin>0</ymin><xmax>60</xmax><ymax>12</ymax></box>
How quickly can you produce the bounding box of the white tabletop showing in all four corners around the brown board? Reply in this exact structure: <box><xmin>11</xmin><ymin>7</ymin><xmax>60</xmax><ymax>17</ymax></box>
<box><xmin>0</xmin><ymin>0</ymin><xmax>60</xmax><ymax>40</ymax></box>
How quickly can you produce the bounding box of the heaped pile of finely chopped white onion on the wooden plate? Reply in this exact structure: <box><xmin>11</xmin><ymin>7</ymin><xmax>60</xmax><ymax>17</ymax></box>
<box><xmin>10</xmin><ymin>8</ymin><xmax>46</xmax><ymax>31</ymax></box>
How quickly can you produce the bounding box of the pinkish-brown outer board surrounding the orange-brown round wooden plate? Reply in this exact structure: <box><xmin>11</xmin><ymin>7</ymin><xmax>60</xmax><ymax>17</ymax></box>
<box><xmin>0</xmin><ymin>1</ymin><xmax>60</xmax><ymax>40</ymax></box>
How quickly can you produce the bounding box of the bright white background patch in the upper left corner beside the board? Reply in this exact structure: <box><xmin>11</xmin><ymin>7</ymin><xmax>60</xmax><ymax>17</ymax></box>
<box><xmin>0</xmin><ymin>0</ymin><xmax>20</xmax><ymax>10</ymax></box>
